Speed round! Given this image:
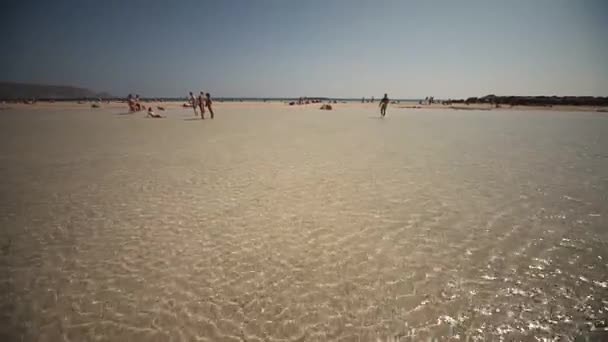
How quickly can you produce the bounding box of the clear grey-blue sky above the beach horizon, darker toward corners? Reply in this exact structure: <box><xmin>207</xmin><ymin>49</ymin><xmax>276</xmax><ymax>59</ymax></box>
<box><xmin>0</xmin><ymin>0</ymin><xmax>608</xmax><ymax>99</ymax></box>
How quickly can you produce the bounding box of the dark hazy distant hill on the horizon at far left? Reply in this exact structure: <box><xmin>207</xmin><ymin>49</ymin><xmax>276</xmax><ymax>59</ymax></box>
<box><xmin>0</xmin><ymin>82</ymin><xmax>112</xmax><ymax>100</ymax></box>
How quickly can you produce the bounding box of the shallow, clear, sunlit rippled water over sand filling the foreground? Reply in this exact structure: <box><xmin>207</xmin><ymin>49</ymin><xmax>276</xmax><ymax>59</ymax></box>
<box><xmin>0</xmin><ymin>104</ymin><xmax>608</xmax><ymax>341</ymax></box>
